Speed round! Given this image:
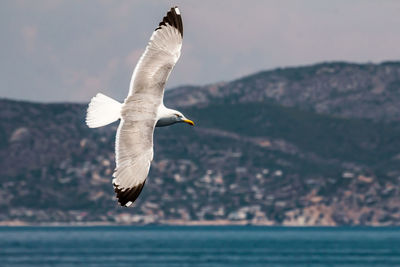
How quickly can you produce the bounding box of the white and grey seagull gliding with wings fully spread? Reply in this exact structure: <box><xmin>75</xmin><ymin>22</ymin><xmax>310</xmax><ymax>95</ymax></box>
<box><xmin>86</xmin><ymin>7</ymin><xmax>194</xmax><ymax>207</ymax></box>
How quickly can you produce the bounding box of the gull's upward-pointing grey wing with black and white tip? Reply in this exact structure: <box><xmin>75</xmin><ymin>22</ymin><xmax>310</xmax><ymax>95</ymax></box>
<box><xmin>128</xmin><ymin>7</ymin><xmax>183</xmax><ymax>99</ymax></box>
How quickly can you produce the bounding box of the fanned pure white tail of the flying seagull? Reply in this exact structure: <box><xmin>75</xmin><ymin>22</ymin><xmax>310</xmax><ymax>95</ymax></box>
<box><xmin>86</xmin><ymin>93</ymin><xmax>122</xmax><ymax>128</ymax></box>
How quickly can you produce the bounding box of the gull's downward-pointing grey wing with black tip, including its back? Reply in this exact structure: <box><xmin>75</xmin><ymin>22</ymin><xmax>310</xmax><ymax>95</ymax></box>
<box><xmin>113</xmin><ymin>105</ymin><xmax>156</xmax><ymax>206</ymax></box>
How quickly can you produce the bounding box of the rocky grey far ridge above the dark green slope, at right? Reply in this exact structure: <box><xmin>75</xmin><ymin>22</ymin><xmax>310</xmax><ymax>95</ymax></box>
<box><xmin>166</xmin><ymin>62</ymin><xmax>400</xmax><ymax>121</ymax></box>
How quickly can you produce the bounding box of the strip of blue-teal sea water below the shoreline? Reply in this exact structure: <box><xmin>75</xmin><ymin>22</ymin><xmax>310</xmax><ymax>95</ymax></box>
<box><xmin>0</xmin><ymin>226</ymin><xmax>400</xmax><ymax>267</ymax></box>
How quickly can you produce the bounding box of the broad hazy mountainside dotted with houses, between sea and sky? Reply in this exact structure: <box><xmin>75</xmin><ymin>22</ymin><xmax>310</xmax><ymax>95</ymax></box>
<box><xmin>0</xmin><ymin>62</ymin><xmax>400</xmax><ymax>225</ymax></box>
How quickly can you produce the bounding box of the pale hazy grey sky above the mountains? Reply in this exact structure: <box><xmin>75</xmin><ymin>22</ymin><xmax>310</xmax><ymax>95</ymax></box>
<box><xmin>0</xmin><ymin>0</ymin><xmax>400</xmax><ymax>102</ymax></box>
